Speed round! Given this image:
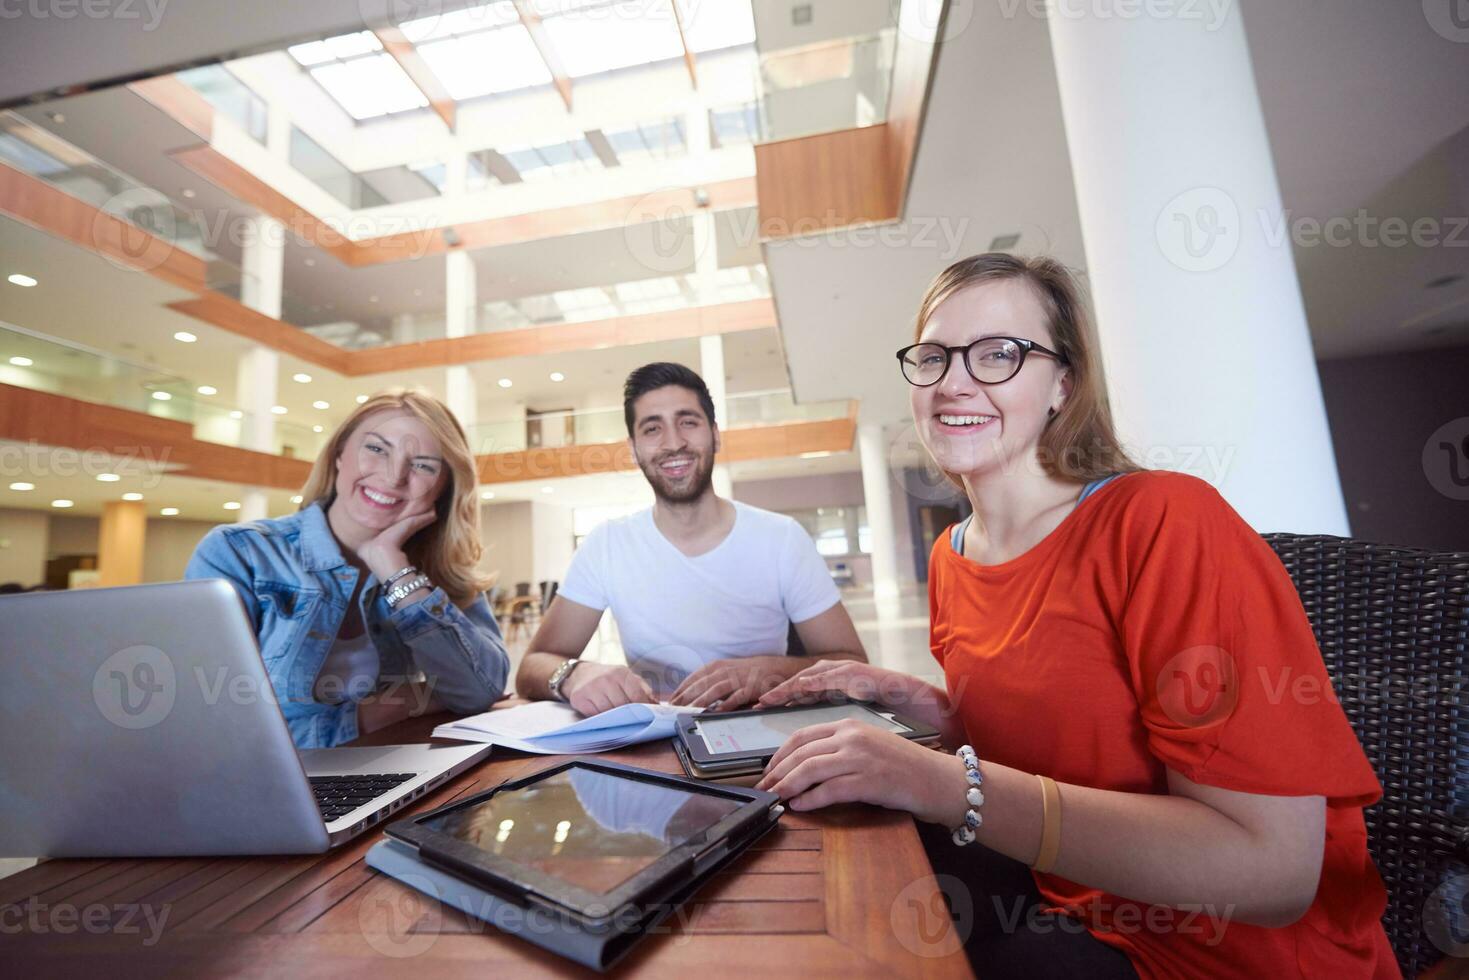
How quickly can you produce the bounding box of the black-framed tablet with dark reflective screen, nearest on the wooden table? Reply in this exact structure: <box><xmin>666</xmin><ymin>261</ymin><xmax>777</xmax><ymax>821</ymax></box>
<box><xmin>386</xmin><ymin>758</ymin><xmax>782</xmax><ymax>929</ymax></box>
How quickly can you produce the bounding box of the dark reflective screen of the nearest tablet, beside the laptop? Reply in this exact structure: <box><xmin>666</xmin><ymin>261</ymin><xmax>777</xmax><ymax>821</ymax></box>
<box><xmin>423</xmin><ymin>765</ymin><xmax>743</xmax><ymax>895</ymax></box>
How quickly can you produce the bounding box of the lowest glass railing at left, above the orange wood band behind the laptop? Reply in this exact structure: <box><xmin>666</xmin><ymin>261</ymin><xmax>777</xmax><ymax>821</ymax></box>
<box><xmin>0</xmin><ymin>325</ymin><xmax>328</xmax><ymax>460</ymax></box>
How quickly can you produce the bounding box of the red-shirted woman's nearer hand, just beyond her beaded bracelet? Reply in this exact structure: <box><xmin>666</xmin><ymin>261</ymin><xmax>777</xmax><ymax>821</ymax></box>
<box><xmin>755</xmin><ymin>720</ymin><xmax>968</xmax><ymax>827</ymax></box>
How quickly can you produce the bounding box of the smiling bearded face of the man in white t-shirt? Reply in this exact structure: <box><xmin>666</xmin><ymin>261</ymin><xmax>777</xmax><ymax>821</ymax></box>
<box><xmin>629</xmin><ymin>385</ymin><xmax>720</xmax><ymax>504</ymax></box>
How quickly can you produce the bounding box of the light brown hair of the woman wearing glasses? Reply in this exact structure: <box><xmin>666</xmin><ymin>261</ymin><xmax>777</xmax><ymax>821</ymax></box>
<box><xmin>914</xmin><ymin>251</ymin><xmax>1140</xmax><ymax>489</ymax></box>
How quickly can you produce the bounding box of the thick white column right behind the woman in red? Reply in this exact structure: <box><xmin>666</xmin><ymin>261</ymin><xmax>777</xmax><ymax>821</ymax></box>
<box><xmin>1050</xmin><ymin>0</ymin><xmax>1347</xmax><ymax>533</ymax></box>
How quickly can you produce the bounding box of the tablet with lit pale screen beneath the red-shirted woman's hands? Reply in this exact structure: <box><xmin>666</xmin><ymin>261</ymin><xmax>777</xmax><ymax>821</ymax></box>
<box><xmin>676</xmin><ymin>701</ymin><xmax>939</xmax><ymax>777</ymax></box>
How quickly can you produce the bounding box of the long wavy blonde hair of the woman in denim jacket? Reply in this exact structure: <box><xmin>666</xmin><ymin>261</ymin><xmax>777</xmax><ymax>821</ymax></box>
<box><xmin>301</xmin><ymin>388</ymin><xmax>495</xmax><ymax>608</ymax></box>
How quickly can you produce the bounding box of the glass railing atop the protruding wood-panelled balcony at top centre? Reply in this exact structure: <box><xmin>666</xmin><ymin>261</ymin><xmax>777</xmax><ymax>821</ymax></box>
<box><xmin>759</xmin><ymin>28</ymin><xmax>898</xmax><ymax>141</ymax></box>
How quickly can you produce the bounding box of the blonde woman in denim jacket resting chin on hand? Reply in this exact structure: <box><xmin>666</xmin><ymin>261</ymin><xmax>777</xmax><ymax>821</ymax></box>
<box><xmin>185</xmin><ymin>388</ymin><xmax>510</xmax><ymax>748</ymax></box>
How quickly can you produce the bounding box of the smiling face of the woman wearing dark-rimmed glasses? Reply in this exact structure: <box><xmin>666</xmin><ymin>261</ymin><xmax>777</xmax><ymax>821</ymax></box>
<box><xmin>909</xmin><ymin>279</ymin><xmax>1069</xmax><ymax>476</ymax></box>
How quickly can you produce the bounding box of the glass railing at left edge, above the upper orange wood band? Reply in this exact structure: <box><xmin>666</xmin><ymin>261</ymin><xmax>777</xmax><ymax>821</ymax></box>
<box><xmin>0</xmin><ymin>112</ymin><xmax>213</xmax><ymax>259</ymax></box>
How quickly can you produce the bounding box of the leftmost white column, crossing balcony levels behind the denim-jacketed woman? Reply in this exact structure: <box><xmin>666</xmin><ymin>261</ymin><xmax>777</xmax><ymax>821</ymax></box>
<box><xmin>235</xmin><ymin>215</ymin><xmax>285</xmax><ymax>522</ymax></box>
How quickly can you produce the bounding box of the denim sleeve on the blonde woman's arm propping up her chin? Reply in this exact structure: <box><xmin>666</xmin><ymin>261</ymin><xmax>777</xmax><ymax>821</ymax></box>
<box><xmin>388</xmin><ymin>589</ymin><xmax>510</xmax><ymax>714</ymax></box>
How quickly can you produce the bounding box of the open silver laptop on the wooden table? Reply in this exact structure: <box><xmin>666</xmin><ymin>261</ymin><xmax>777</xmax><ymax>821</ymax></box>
<box><xmin>0</xmin><ymin>579</ymin><xmax>489</xmax><ymax>858</ymax></box>
